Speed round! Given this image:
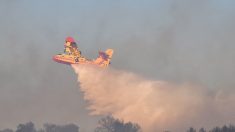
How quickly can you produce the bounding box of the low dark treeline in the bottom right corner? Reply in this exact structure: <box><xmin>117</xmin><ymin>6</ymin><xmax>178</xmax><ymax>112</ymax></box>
<box><xmin>187</xmin><ymin>125</ymin><xmax>235</xmax><ymax>132</ymax></box>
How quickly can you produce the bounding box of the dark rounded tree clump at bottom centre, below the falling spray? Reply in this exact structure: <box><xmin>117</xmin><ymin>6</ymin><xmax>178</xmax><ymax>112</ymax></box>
<box><xmin>95</xmin><ymin>116</ymin><xmax>141</xmax><ymax>132</ymax></box>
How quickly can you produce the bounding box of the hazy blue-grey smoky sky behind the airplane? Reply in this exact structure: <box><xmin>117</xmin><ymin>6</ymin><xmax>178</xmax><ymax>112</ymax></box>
<box><xmin>0</xmin><ymin>0</ymin><xmax>235</xmax><ymax>132</ymax></box>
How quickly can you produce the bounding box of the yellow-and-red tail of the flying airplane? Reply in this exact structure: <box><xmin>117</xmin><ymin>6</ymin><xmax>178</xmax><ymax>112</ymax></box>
<box><xmin>95</xmin><ymin>49</ymin><xmax>114</xmax><ymax>67</ymax></box>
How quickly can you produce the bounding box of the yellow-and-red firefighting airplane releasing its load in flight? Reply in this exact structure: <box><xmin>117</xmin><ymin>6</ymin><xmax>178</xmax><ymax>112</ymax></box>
<box><xmin>53</xmin><ymin>37</ymin><xmax>113</xmax><ymax>67</ymax></box>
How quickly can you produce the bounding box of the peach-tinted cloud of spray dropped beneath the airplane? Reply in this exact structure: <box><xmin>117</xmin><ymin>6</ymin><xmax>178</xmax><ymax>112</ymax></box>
<box><xmin>72</xmin><ymin>65</ymin><xmax>235</xmax><ymax>132</ymax></box>
